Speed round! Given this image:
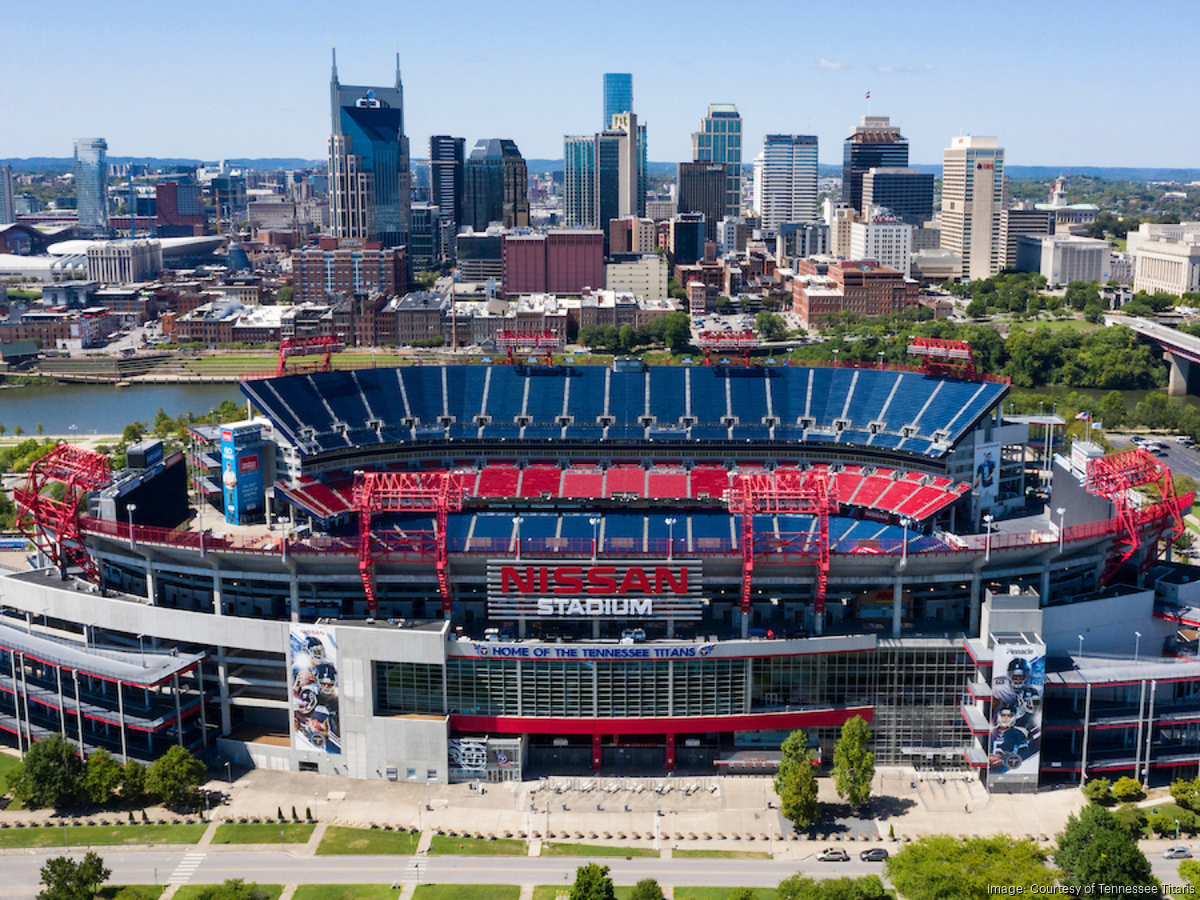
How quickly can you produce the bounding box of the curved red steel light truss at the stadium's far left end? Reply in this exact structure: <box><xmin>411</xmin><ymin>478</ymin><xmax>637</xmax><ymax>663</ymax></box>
<box><xmin>13</xmin><ymin>444</ymin><xmax>113</xmax><ymax>582</ymax></box>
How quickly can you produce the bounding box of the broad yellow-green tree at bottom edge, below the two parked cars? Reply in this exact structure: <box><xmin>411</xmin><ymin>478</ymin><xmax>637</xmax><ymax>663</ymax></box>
<box><xmin>884</xmin><ymin>834</ymin><xmax>1055</xmax><ymax>900</ymax></box>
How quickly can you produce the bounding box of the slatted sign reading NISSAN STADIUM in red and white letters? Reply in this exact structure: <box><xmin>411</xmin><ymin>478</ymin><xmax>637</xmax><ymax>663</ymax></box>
<box><xmin>487</xmin><ymin>559</ymin><xmax>702</xmax><ymax>622</ymax></box>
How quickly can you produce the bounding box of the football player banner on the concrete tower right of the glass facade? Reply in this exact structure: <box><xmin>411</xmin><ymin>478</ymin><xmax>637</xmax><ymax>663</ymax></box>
<box><xmin>988</xmin><ymin>644</ymin><xmax>1046</xmax><ymax>776</ymax></box>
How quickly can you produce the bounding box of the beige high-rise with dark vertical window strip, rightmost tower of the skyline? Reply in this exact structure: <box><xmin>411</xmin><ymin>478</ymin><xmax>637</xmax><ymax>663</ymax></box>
<box><xmin>942</xmin><ymin>134</ymin><xmax>1006</xmax><ymax>281</ymax></box>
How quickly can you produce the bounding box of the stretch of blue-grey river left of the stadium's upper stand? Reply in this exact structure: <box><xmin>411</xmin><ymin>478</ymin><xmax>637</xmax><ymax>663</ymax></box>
<box><xmin>0</xmin><ymin>384</ymin><xmax>246</xmax><ymax>436</ymax></box>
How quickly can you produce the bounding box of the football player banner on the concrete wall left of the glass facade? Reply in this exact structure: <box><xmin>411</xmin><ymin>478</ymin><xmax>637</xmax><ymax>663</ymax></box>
<box><xmin>288</xmin><ymin>625</ymin><xmax>342</xmax><ymax>754</ymax></box>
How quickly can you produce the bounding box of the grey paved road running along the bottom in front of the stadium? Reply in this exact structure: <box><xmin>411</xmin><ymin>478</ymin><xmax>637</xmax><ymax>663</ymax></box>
<box><xmin>0</xmin><ymin>845</ymin><xmax>1183</xmax><ymax>900</ymax></box>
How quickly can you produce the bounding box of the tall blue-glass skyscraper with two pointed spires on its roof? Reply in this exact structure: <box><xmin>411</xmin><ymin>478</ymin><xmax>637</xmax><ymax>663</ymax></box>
<box><xmin>329</xmin><ymin>50</ymin><xmax>412</xmax><ymax>247</ymax></box>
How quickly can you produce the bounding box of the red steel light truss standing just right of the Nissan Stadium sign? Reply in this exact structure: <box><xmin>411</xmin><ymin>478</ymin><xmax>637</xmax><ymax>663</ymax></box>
<box><xmin>728</xmin><ymin>469</ymin><xmax>839</xmax><ymax>616</ymax></box>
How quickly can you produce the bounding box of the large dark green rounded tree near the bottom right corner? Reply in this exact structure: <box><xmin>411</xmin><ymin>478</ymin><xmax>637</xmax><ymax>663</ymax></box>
<box><xmin>1056</xmin><ymin>803</ymin><xmax>1158</xmax><ymax>892</ymax></box>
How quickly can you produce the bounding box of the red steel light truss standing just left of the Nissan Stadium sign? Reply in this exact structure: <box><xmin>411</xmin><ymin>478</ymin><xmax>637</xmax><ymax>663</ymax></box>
<box><xmin>354</xmin><ymin>472</ymin><xmax>467</xmax><ymax>616</ymax></box>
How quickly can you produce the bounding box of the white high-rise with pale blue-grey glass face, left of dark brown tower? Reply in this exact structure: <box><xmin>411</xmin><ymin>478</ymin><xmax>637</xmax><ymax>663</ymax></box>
<box><xmin>754</xmin><ymin>134</ymin><xmax>818</xmax><ymax>234</ymax></box>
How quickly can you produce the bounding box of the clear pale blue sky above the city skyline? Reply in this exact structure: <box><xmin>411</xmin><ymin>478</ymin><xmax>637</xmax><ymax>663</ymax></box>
<box><xmin>0</xmin><ymin>0</ymin><xmax>1200</xmax><ymax>168</ymax></box>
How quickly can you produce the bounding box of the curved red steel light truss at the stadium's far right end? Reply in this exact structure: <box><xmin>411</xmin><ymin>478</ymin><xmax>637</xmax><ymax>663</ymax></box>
<box><xmin>1087</xmin><ymin>448</ymin><xmax>1183</xmax><ymax>587</ymax></box>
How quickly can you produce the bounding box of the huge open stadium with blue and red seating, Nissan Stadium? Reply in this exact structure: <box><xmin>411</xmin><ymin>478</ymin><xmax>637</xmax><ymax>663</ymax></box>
<box><xmin>0</xmin><ymin>337</ymin><xmax>1200</xmax><ymax>791</ymax></box>
